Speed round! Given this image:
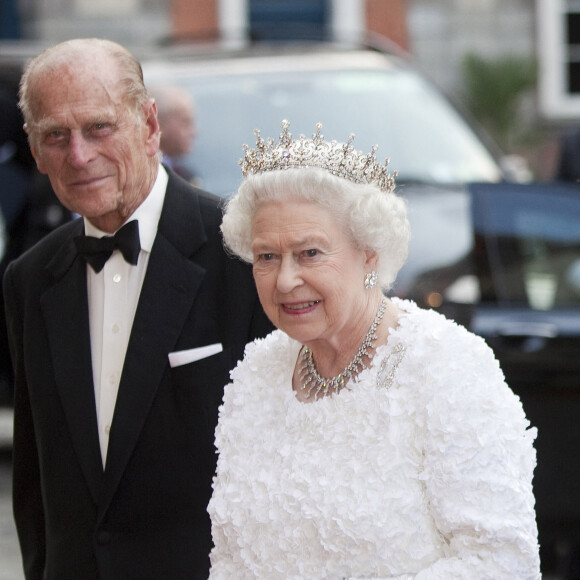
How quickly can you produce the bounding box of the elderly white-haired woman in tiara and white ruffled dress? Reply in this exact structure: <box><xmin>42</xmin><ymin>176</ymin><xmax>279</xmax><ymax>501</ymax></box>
<box><xmin>208</xmin><ymin>122</ymin><xmax>540</xmax><ymax>580</ymax></box>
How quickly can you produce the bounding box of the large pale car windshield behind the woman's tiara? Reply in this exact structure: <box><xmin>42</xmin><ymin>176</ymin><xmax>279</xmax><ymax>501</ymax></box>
<box><xmin>145</xmin><ymin>56</ymin><xmax>501</xmax><ymax>195</ymax></box>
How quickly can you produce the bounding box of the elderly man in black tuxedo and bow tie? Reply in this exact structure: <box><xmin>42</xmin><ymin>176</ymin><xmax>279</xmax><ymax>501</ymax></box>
<box><xmin>4</xmin><ymin>39</ymin><xmax>270</xmax><ymax>580</ymax></box>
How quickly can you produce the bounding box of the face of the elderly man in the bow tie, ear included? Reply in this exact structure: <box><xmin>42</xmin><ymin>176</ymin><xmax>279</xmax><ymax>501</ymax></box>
<box><xmin>27</xmin><ymin>58</ymin><xmax>159</xmax><ymax>231</ymax></box>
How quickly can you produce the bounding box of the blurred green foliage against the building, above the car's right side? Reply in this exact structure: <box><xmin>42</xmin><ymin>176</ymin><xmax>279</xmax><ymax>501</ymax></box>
<box><xmin>463</xmin><ymin>54</ymin><xmax>538</xmax><ymax>152</ymax></box>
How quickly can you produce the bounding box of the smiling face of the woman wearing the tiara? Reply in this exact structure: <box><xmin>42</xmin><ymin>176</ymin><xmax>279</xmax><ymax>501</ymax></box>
<box><xmin>252</xmin><ymin>201</ymin><xmax>376</xmax><ymax>347</ymax></box>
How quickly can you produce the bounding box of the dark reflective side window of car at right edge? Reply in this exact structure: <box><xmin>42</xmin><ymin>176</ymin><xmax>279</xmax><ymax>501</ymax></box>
<box><xmin>472</xmin><ymin>184</ymin><xmax>580</xmax><ymax>310</ymax></box>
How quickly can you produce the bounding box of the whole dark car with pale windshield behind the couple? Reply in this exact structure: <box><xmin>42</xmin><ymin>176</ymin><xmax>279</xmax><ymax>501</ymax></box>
<box><xmin>144</xmin><ymin>47</ymin><xmax>580</xmax><ymax>578</ymax></box>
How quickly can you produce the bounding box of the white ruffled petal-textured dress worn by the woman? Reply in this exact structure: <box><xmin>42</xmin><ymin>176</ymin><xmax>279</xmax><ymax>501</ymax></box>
<box><xmin>208</xmin><ymin>301</ymin><xmax>540</xmax><ymax>580</ymax></box>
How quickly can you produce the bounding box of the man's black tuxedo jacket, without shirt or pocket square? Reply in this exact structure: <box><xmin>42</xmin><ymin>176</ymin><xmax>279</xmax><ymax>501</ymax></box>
<box><xmin>4</xmin><ymin>173</ymin><xmax>271</xmax><ymax>580</ymax></box>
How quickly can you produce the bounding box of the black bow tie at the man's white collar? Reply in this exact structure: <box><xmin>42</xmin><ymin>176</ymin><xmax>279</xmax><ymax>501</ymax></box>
<box><xmin>75</xmin><ymin>220</ymin><xmax>141</xmax><ymax>272</ymax></box>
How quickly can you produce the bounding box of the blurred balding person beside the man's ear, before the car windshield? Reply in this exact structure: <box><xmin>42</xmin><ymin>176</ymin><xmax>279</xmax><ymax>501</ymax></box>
<box><xmin>149</xmin><ymin>85</ymin><xmax>198</xmax><ymax>185</ymax></box>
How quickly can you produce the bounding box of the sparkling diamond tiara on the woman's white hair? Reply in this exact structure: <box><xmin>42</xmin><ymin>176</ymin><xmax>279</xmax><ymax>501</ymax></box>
<box><xmin>239</xmin><ymin>119</ymin><xmax>397</xmax><ymax>192</ymax></box>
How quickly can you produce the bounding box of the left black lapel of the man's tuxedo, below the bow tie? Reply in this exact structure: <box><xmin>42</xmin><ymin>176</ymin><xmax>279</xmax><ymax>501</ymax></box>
<box><xmin>41</xmin><ymin>232</ymin><xmax>103</xmax><ymax>503</ymax></box>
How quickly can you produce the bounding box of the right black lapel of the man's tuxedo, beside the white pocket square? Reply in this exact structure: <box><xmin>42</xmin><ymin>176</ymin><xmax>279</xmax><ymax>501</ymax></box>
<box><xmin>99</xmin><ymin>180</ymin><xmax>205</xmax><ymax>515</ymax></box>
